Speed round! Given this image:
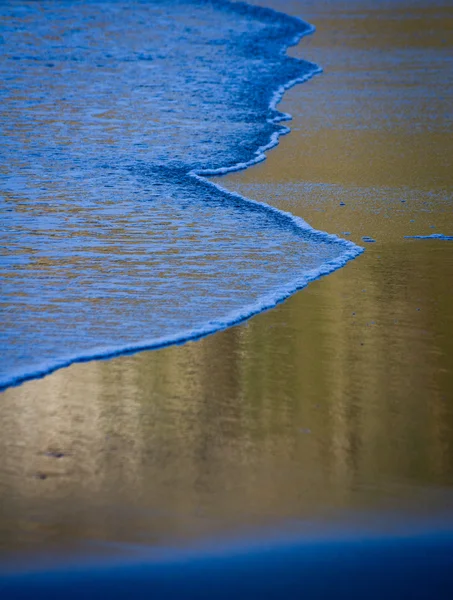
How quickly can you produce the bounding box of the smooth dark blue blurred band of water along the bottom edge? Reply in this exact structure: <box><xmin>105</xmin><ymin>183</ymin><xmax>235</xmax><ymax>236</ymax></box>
<box><xmin>0</xmin><ymin>528</ymin><xmax>453</xmax><ymax>600</ymax></box>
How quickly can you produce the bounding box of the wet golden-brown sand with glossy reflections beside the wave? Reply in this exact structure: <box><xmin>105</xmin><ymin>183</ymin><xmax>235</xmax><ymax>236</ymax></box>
<box><xmin>0</xmin><ymin>0</ymin><xmax>453</xmax><ymax>553</ymax></box>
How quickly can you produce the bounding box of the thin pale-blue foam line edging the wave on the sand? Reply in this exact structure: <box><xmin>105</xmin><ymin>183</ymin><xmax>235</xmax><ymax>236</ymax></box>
<box><xmin>0</xmin><ymin>2</ymin><xmax>364</xmax><ymax>391</ymax></box>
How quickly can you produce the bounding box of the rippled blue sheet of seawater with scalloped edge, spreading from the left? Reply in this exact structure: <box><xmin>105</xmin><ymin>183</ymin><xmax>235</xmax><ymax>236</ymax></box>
<box><xmin>0</xmin><ymin>0</ymin><xmax>361</xmax><ymax>388</ymax></box>
